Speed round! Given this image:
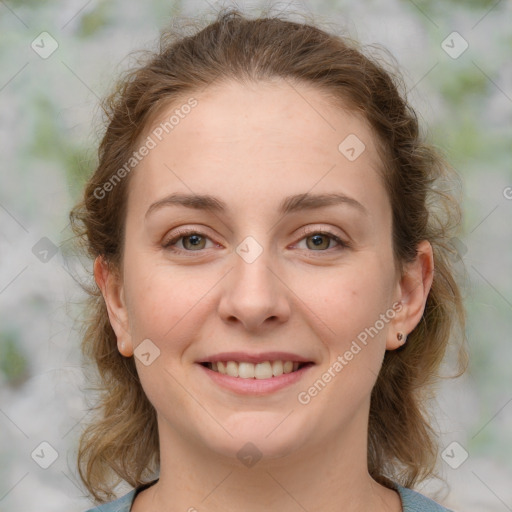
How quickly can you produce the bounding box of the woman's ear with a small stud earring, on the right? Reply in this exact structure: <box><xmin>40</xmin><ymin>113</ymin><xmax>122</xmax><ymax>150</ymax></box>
<box><xmin>386</xmin><ymin>240</ymin><xmax>434</xmax><ymax>350</ymax></box>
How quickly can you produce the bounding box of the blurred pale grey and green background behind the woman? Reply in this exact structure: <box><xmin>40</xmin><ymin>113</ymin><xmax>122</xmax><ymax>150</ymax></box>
<box><xmin>0</xmin><ymin>0</ymin><xmax>512</xmax><ymax>512</ymax></box>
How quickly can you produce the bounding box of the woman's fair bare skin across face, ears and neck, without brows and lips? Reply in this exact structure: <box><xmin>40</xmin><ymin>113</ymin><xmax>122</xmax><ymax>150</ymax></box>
<box><xmin>94</xmin><ymin>80</ymin><xmax>433</xmax><ymax>512</ymax></box>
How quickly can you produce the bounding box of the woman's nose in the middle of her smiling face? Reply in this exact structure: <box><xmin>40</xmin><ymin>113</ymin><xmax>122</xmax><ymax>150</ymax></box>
<box><xmin>218</xmin><ymin>243</ymin><xmax>291</xmax><ymax>332</ymax></box>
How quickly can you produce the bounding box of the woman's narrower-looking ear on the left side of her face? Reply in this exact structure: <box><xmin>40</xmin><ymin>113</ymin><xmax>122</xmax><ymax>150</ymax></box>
<box><xmin>94</xmin><ymin>256</ymin><xmax>133</xmax><ymax>357</ymax></box>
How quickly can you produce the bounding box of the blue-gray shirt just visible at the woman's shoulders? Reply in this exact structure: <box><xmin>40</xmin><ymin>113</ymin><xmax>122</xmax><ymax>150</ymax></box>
<box><xmin>86</xmin><ymin>480</ymin><xmax>452</xmax><ymax>512</ymax></box>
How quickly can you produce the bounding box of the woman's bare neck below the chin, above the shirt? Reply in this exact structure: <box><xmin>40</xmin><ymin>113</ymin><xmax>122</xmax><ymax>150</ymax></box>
<box><xmin>138</xmin><ymin>410</ymin><xmax>402</xmax><ymax>512</ymax></box>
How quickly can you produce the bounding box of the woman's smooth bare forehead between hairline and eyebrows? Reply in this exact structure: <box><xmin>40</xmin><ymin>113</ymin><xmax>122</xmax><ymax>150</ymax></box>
<box><xmin>128</xmin><ymin>79</ymin><xmax>385</xmax><ymax>219</ymax></box>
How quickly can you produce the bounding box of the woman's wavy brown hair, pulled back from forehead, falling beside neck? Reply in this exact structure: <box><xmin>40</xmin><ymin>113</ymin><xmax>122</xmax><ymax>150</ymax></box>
<box><xmin>70</xmin><ymin>8</ymin><xmax>466</xmax><ymax>502</ymax></box>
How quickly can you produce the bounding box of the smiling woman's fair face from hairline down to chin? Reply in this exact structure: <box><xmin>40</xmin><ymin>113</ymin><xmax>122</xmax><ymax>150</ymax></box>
<box><xmin>96</xmin><ymin>81</ymin><xmax>428</xmax><ymax>464</ymax></box>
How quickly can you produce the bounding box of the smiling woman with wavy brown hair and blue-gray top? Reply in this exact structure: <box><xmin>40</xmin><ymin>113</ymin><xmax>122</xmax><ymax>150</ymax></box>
<box><xmin>71</xmin><ymin>5</ymin><xmax>464</xmax><ymax>512</ymax></box>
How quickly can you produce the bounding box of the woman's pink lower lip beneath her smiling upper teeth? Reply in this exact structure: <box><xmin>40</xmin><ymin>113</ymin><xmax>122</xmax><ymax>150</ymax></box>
<box><xmin>198</xmin><ymin>363</ymin><xmax>314</xmax><ymax>395</ymax></box>
